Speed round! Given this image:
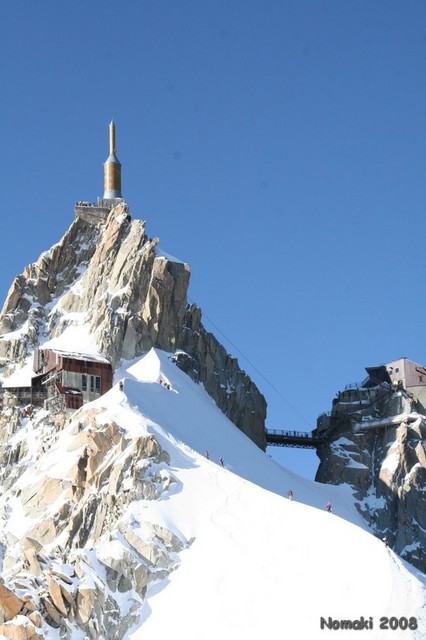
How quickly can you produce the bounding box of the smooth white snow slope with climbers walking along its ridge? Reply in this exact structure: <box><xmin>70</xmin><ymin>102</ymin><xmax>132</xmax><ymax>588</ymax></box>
<box><xmin>102</xmin><ymin>350</ymin><xmax>426</xmax><ymax>640</ymax></box>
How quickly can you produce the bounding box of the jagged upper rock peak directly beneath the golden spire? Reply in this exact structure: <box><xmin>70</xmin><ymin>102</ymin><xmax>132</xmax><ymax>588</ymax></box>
<box><xmin>0</xmin><ymin>203</ymin><xmax>266</xmax><ymax>448</ymax></box>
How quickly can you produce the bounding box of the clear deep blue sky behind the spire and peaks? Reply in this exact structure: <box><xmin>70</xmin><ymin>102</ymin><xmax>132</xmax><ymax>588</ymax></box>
<box><xmin>0</xmin><ymin>0</ymin><xmax>426</xmax><ymax>477</ymax></box>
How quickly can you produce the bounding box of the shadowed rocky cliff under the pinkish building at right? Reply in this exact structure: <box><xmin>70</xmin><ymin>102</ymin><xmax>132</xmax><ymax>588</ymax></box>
<box><xmin>316</xmin><ymin>384</ymin><xmax>426</xmax><ymax>572</ymax></box>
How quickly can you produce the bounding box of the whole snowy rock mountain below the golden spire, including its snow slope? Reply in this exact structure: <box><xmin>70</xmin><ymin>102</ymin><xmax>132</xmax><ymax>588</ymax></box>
<box><xmin>0</xmin><ymin>208</ymin><xmax>426</xmax><ymax>640</ymax></box>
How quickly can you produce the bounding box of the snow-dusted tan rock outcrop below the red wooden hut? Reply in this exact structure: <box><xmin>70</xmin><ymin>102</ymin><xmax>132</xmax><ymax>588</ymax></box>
<box><xmin>0</xmin><ymin>380</ymin><xmax>191</xmax><ymax>640</ymax></box>
